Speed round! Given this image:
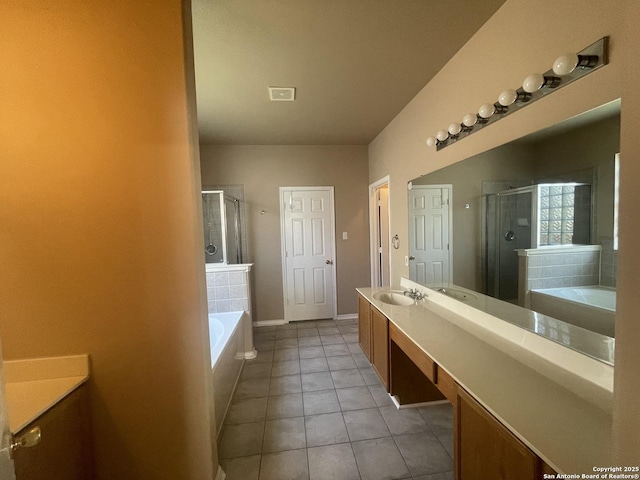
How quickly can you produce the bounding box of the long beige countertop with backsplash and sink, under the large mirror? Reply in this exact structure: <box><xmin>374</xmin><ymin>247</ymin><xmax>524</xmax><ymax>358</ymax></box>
<box><xmin>357</xmin><ymin>279</ymin><xmax>613</xmax><ymax>474</ymax></box>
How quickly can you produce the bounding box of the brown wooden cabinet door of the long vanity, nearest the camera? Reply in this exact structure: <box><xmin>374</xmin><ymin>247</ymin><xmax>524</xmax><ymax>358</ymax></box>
<box><xmin>457</xmin><ymin>390</ymin><xmax>540</xmax><ymax>480</ymax></box>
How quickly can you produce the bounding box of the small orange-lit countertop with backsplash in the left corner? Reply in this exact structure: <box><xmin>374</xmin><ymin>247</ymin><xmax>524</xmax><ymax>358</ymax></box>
<box><xmin>3</xmin><ymin>355</ymin><xmax>89</xmax><ymax>434</ymax></box>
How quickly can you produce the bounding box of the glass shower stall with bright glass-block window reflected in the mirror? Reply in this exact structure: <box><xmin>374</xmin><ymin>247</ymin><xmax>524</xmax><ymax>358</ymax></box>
<box><xmin>486</xmin><ymin>183</ymin><xmax>592</xmax><ymax>303</ymax></box>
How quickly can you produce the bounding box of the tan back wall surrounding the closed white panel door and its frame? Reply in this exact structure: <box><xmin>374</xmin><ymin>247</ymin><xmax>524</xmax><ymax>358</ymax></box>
<box><xmin>200</xmin><ymin>145</ymin><xmax>371</xmax><ymax>320</ymax></box>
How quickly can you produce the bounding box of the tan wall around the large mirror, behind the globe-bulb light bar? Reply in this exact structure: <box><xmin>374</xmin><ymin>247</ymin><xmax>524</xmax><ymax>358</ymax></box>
<box><xmin>369</xmin><ymin>0</ymin><xmax>640</xmax><ymax>464</ymax></box>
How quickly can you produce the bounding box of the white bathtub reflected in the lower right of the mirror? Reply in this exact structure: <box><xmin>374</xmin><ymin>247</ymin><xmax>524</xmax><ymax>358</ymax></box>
<box><xmin>531</xmin><ymin>285</ymin><xmax>616</xmax><ymax>337</ymax></box>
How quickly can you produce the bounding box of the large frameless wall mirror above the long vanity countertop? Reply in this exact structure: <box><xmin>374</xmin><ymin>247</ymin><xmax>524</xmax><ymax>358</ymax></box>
<box><xmin>408</xmin><ymin>101</ymin><xmax>620</xmax><ymax>364</ymax></box>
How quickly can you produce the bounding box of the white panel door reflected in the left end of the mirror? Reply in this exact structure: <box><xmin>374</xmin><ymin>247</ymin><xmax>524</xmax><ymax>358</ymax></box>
<box><xmin>409</xmin><ymin>185</ymin><xmax>451</xmax><ymax>285</ymax></box>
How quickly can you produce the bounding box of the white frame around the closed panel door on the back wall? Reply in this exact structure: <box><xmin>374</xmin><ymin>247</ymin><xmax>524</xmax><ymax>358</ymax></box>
<box><xmin>278</xmin><ymin>186</ymin><xmax>338</xmax><ymax>323</ymax></box>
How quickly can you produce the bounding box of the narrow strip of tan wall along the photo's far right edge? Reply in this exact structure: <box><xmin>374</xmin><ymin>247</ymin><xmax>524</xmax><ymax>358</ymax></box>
<box><xmin>613</xmin><ymin>0</ymin><xmax>640</xmax><ymax>465</ymax></box>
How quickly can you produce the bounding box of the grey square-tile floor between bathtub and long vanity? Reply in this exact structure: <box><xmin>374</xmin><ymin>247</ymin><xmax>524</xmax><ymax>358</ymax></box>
<box><xmin>218</xmin><ymin>320</ymin><xmax>453</xmax><ymax>480</ymax></box>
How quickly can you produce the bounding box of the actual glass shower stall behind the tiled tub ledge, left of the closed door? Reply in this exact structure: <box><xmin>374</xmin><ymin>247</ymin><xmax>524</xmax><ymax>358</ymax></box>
<box><xmin>202</xmin><ymin>190</ymin><xmax>243</xmax><ymax>265</ymax></box>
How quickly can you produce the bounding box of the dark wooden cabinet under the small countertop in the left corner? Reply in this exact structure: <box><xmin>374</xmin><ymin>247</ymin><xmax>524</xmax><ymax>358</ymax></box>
<box><xmin>14</xmin><ymin>385</ymin><xmax>94</xmax><ymax>480</ymax></box>
